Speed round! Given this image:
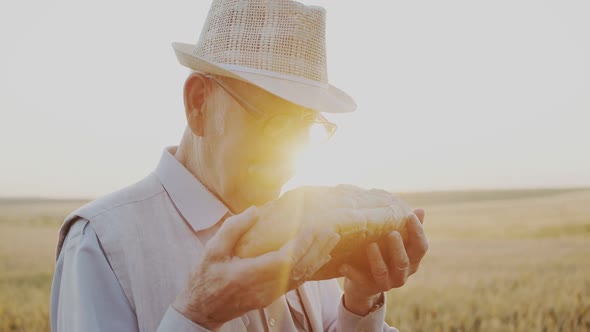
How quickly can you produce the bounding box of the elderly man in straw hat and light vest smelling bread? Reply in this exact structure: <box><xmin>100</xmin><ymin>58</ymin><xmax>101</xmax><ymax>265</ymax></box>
<box><xmin>51</xmin><ymin>0</ymin><xmax>427</xmax><ymax>331</ymax></box>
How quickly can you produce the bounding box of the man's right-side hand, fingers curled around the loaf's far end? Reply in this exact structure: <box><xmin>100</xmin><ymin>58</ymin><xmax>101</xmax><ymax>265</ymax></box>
<box><xmin>340</xmin><ymin>209</ymin><xmax>428</xmax><ymax>316</ymax></box>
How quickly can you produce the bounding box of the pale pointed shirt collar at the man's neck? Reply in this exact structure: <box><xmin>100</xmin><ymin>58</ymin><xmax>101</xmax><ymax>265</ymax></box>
<box><xmin>155</xmin><ymin>147</ymin><xmax>229</xmax><ymax>232</ymax></box>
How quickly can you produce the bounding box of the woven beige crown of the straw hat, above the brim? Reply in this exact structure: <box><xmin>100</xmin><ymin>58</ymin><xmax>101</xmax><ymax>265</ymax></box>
<box><xmin>193</xmin><ymin>0</ymin><xmax>328</xmax><ymax>85</ymax></box>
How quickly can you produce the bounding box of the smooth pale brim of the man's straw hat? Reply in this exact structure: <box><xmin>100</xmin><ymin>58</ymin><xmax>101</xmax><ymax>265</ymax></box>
<box><xmin>172</xmin><ymin>43</ymin><xmax>356</xmax><ymax>113</ymax></box>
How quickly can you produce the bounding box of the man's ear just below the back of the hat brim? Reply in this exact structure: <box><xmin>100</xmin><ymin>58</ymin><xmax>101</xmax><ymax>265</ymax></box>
<box><xmin>184</xmin><ymin>73</ymin><xmax>209</xmax><ymax>136</ymax></box>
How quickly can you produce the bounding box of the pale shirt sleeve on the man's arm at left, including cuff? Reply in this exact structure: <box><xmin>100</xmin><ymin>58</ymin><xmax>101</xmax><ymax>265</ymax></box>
<box><xmin>50</xmin><ymin>219</ymin><xmax>213</xmax><ymax>332</ymax></box>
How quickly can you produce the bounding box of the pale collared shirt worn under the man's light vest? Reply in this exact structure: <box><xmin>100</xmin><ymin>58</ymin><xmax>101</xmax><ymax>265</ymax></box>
<box><xmin>51</xmin><ymin>148</ymin><xmax>396</xmax><ymax>332</ymax></box>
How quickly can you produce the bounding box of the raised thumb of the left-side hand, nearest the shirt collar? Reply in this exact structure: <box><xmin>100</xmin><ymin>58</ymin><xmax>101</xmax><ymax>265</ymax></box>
<box><xmin>208</xmin><ymin>206</ymin><xmax>258</xmax><ymax>259</ymax></box>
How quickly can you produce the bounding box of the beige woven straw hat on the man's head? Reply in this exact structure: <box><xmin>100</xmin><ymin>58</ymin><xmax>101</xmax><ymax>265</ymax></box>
<box><xmin>172</xmin><ymin>0</ymin><xmax>356</xmax><ymax>113</ymax></box>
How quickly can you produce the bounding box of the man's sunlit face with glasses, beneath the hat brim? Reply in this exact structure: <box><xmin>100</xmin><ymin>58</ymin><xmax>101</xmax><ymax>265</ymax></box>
<box><xmin>205</xmin><ymin>78</ymin><xmax>324</xmax><ymax>212</ymax></box>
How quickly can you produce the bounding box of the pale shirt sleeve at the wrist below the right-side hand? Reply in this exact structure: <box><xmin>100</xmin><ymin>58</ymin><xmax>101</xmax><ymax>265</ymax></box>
<box><xmin>318</xmin><ymin>279</ymin><xmax>398</xmax><ymax>332</ymax></box>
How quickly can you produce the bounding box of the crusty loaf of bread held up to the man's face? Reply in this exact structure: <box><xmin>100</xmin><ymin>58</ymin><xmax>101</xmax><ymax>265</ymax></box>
<box><xmin>235</xmin><ymin>185</ymin><xmax>412</xmax><ymax>280</ymax></box>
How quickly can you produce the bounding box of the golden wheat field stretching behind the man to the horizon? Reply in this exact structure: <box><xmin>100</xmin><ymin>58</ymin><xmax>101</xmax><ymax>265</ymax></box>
<box><xmin>0</xmin><ymin>189</ymin><xmax>590</xmax><ymax>331</ymax></box>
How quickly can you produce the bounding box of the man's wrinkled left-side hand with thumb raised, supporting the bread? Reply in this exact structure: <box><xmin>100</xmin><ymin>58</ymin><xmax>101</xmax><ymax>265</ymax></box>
<box><xmin>172</xmin><ymin>207</ymin><xmax>340</xmax><ymax>329</ymax></box>
